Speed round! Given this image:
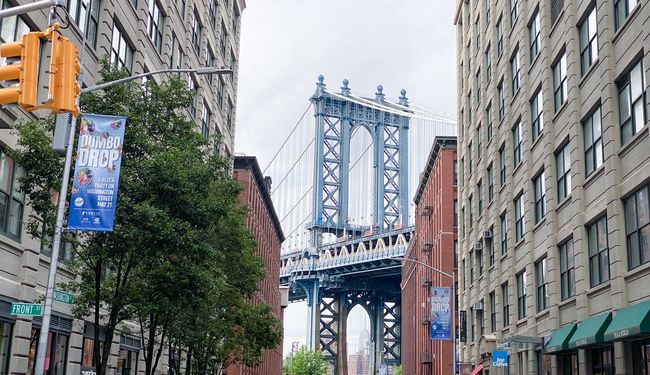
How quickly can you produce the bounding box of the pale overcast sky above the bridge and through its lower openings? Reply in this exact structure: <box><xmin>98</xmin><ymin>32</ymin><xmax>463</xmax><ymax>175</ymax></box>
<box><xmin>235</xmin><ymin>0</ymin><xmax>456</xmax><ymax>354</ymax></box>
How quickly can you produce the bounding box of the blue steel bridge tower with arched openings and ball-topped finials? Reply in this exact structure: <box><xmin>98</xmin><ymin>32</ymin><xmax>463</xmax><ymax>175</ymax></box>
<box><xmin>296</xmin><ymin>75</ymin><xmax>404</xmax><ymax>374</ymax></box>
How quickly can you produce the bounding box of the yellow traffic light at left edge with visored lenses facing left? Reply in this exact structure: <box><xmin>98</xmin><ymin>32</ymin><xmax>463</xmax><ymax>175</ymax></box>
<box><xmin>0</xmin><ymin>32</ymin><xmax>42</xmax><ymax>111</ymax></box>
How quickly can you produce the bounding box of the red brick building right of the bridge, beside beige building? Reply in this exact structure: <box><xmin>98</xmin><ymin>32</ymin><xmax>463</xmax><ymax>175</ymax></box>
<box><xmin>401</xmin><ymin>137</ymin><xmax>457</xmax><ymax>375</ymax></box>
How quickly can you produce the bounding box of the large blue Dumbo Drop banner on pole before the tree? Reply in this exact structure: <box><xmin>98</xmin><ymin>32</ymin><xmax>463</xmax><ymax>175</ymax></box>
<box><xmin>68</xmin><ymin>114</ymin><xmax>126</xmax><ymax>232</ymax></box>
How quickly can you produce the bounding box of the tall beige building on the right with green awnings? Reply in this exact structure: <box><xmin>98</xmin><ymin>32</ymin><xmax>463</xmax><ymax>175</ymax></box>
<box><xmin>455</xmin><ymin>0</ymin><xmax>650</xmax><ymax>374</ymax></box>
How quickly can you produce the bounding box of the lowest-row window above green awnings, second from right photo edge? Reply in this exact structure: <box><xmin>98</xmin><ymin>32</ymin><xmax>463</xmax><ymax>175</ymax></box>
<box><xmin>587</xmin><ymin>216</ymin><xmax>609</xmax><ymax>287</ymax></box>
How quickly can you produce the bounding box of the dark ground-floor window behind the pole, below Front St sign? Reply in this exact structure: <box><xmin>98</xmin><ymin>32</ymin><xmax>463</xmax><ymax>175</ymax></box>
<box><xmin>27</xmin><ymin>328</ymin><xmax>69</xmax><ymax>375</ymax></box>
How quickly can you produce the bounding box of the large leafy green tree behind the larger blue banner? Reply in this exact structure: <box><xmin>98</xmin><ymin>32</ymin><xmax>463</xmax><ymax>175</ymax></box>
<box><xmin>12</xmin><ymin>62</ymin><xmax>279</xmax><ymax>375</ymax></box>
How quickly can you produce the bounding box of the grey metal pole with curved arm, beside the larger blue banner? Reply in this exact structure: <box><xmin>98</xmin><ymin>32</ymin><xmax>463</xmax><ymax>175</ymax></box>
<box><xmin>34</xmin><ymin>65</ymin><xmax>233</xmax><ymax>375</ymax></box>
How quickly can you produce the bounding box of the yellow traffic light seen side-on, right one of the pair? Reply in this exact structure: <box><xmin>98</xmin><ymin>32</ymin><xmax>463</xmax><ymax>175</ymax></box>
<box><xmin>47</xmin><ymin>34</ymin><xmax>81</xmax><ymax>116</ymax></box>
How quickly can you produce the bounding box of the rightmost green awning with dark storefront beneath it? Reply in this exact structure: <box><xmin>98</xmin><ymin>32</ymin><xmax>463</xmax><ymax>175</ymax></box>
<box><xmin>605</xmin><ymin>301</ymin><xmax>650</xmax><ymax>375</ymax></box>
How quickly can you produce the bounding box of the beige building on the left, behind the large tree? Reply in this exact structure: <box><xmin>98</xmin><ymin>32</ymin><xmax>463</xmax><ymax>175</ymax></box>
<box><xmin>0</xmin><ymin>0</ymin><xmax>246</xmax><ymax>375</ymax></box>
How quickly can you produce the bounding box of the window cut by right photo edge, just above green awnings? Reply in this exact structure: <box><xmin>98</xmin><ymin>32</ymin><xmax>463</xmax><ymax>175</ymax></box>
<box><xmin>624</xmin><ymin>184</ymin><xmax>650</xmax><ymax>269</ymax></box>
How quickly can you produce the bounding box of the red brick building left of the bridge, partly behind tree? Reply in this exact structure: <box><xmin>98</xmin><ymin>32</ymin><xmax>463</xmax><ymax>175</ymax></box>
<box><xmin>225</xmin><ymin>156</ymin><xmax>284</xmax><ymax>375</ymax></box>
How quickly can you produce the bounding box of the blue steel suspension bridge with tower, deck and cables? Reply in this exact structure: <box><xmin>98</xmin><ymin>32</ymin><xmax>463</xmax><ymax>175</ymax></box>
<box><xmin>264</xmin><ymin>75</ymin><xmax>456</xmax><ymax>375</ymax></box>
